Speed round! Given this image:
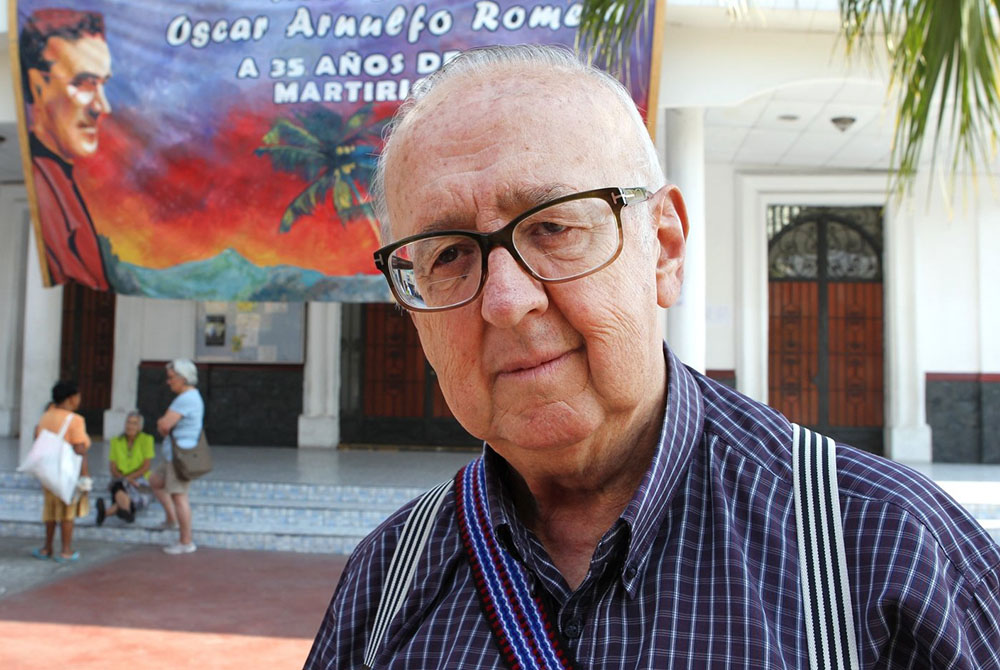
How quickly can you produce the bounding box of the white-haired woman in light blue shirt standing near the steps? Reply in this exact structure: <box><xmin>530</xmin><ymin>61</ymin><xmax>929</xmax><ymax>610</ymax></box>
<box><xmin>150</xmin><ymin>358</ymin><xmax>205</xmax><ymax>554</ymax></box>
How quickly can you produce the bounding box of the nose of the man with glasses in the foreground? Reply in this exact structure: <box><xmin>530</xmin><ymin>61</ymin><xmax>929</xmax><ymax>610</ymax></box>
<box><xmin>482</xmin><ymin>248</ymin><xmax>548</xmax><ymax>328</ymax></box>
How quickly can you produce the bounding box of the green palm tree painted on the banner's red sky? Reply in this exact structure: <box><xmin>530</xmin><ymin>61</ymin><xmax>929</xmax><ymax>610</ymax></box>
<box><xmin>254</xmin><ymin>105</ymin><xmax>385</xmax><ymax>233</ymax></box>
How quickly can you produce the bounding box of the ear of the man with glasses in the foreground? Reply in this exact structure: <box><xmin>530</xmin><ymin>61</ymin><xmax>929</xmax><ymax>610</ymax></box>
<box><xmin>653</xmin><ymin>184</ymin><xmax>688</xmax><ymax>308</ymax></box>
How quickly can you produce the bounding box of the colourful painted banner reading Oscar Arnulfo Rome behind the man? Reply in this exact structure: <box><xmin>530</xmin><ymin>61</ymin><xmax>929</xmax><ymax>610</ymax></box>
<box><xmin>10</xmin><ymin>0</ymin><xmax>658</xmax><ymax>302</ymax></box>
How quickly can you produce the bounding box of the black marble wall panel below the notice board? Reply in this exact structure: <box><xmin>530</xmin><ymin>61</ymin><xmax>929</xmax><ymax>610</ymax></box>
<box><xmin>138</xmin><ymin>363</ymin><xmax>303</xmax><ymax>447</ymax></box>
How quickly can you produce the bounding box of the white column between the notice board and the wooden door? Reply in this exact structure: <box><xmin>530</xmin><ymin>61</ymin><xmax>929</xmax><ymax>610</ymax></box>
<box><xmin>299</xmin><ymin>302</ymin><xmax>341</xmax><ymax>448</ymax></box>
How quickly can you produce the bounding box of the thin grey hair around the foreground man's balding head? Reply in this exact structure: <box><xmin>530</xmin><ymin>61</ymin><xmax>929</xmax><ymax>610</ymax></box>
<box><xmin>371</xmin><ymin>44</ymin><xmax>666</xmax><ymax>244</ymax></box>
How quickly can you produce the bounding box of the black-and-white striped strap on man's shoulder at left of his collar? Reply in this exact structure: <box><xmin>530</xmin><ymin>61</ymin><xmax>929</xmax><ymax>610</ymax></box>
<box><xmin>364</xmin><ymin>479</ymin><xmax>452</xmax><ymax>668</ymax></box>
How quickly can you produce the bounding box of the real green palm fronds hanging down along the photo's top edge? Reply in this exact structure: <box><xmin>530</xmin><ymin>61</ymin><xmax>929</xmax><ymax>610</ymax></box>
<box><xmin>578</xmin><ymin>0</ymin><xmax>1000</xmax><ymax>191</ymax></box>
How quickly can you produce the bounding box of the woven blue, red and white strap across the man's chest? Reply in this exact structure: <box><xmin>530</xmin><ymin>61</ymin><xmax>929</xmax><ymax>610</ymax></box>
<box><xmin>455</xmin><ymin>458</ymin><xmax>572</xmax><ymax>670</ymax></box>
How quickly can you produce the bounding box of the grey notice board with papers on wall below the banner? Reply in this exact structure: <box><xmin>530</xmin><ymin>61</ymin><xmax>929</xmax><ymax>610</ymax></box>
<box><xmin>195</xmin><ymin>301</ymin><xmax>305</xmax><ymax>363</ymax></box>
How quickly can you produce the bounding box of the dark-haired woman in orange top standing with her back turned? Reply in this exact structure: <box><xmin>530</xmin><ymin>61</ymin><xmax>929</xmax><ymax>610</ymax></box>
<box><xmin>32</xmin><ymin>381</ymin><xmax>90</xmax><ymax>563</ymax></box>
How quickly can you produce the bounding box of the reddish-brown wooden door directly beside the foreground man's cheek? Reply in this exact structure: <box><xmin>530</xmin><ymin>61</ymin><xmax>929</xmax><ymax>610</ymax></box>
<box><xmin>341</xmin><ymin>304</ymin><xmax>479</xmax><ymax>446</ymax></box>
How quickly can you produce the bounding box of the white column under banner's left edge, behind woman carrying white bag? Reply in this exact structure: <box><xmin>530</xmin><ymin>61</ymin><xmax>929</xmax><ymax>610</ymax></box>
<box><xmin>18</xmin><ymin>230</ymin><xmax>63</xmax><ymax>462</ymax></box>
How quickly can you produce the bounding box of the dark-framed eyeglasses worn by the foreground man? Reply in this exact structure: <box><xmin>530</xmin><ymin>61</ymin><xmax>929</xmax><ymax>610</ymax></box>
<box><xmin>375</xmin><ymin>187</ymin><xmax>652</xmax><ymax>312</ymax></box>
